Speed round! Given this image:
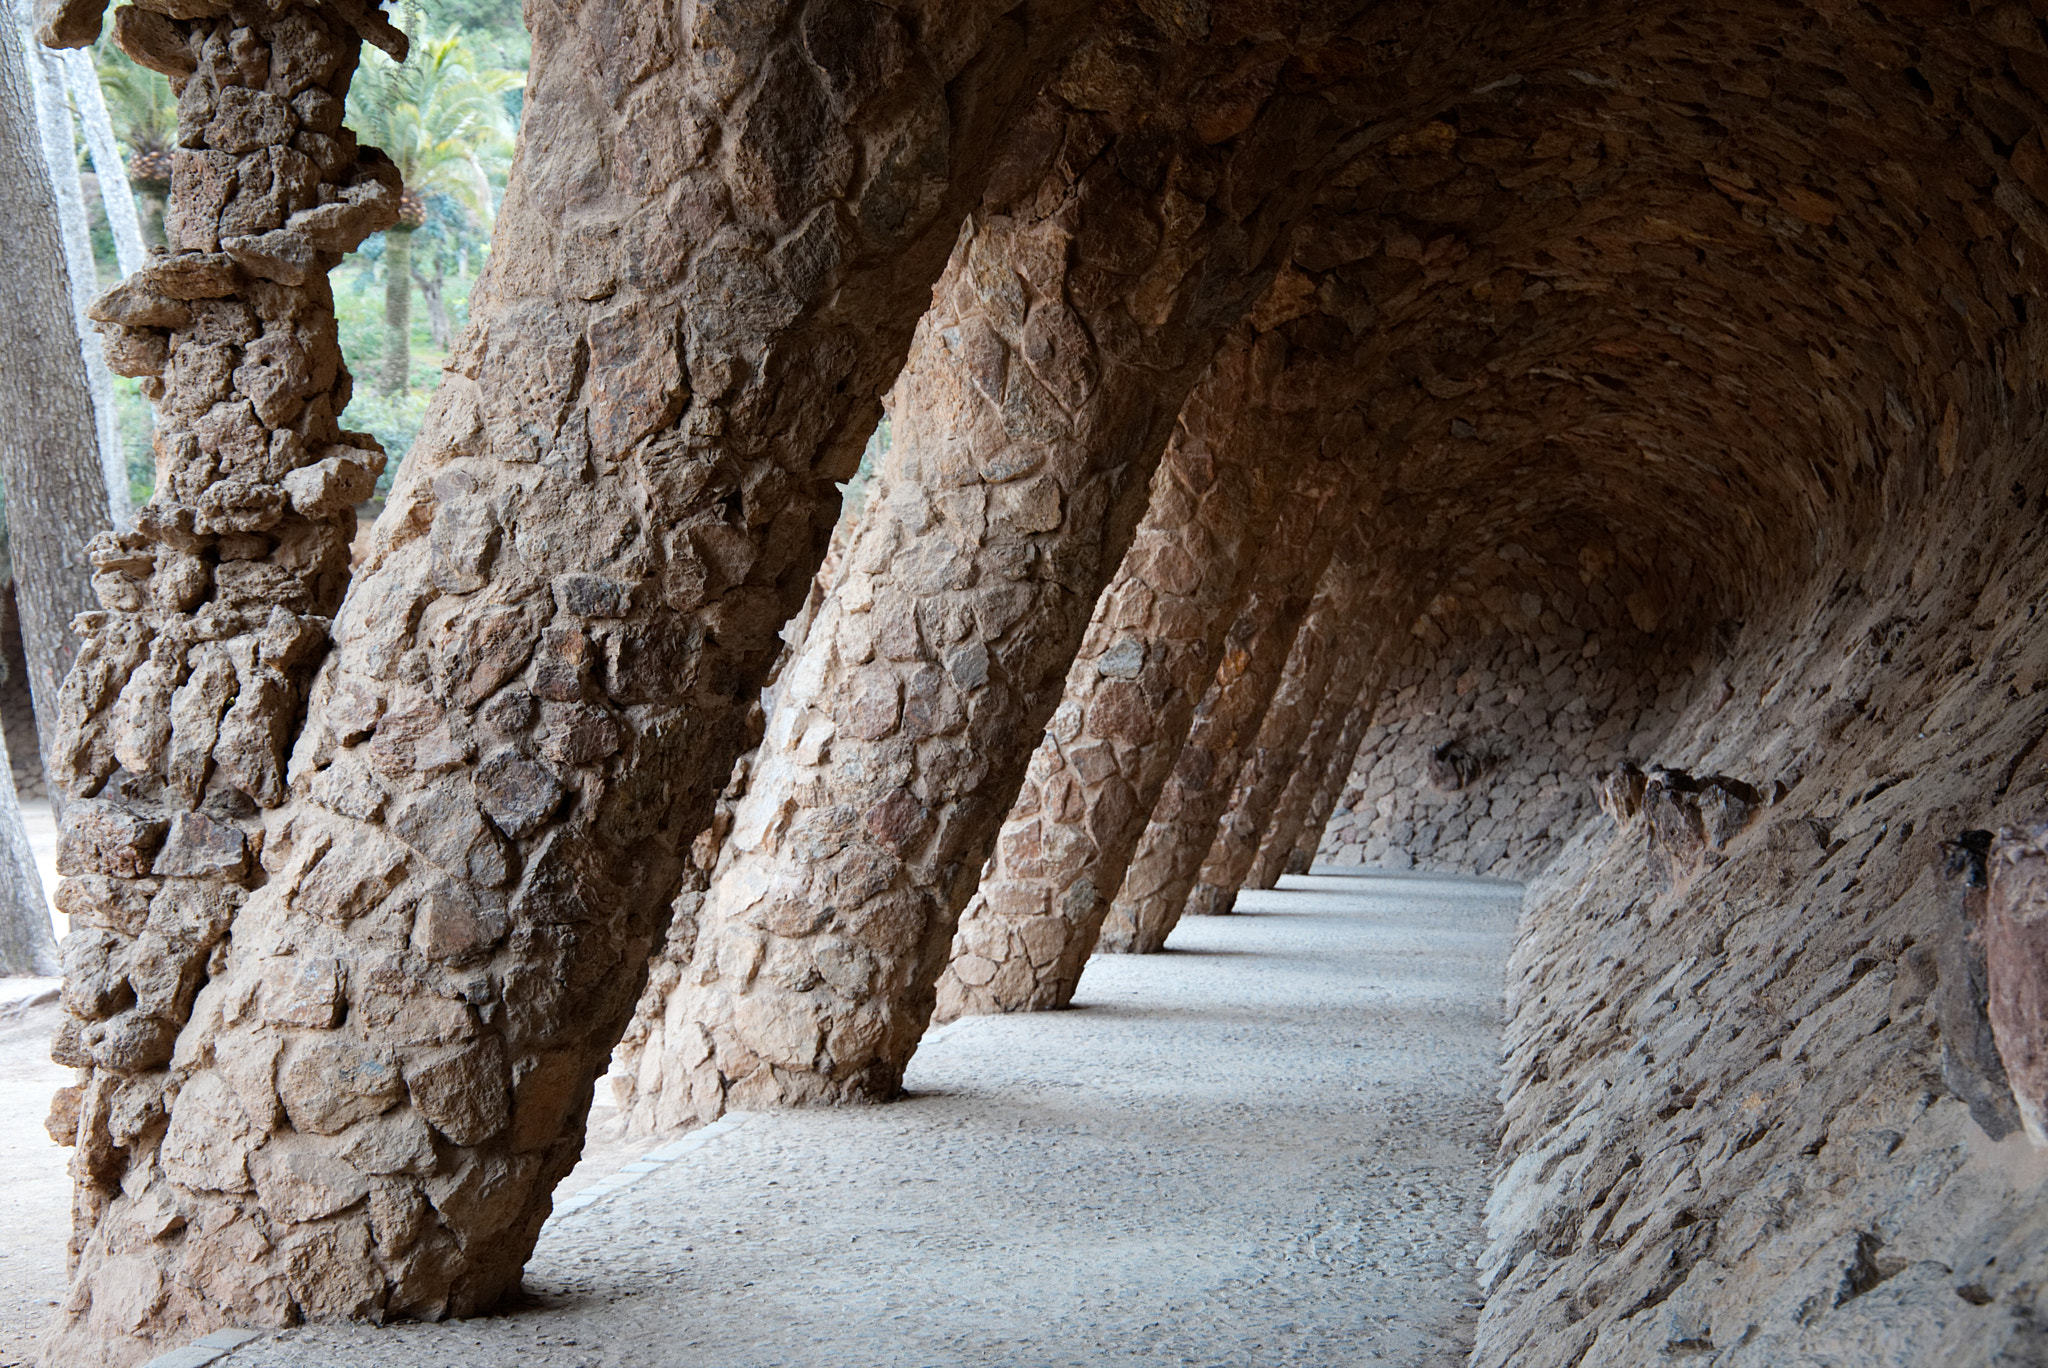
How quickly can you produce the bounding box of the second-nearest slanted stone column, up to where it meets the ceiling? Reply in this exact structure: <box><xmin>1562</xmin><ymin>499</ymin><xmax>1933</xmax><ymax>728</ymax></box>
<box><xmin>606</xmin><ymin>4</ymin><xmax>1630</xmax><ymax>1089</ymax></box>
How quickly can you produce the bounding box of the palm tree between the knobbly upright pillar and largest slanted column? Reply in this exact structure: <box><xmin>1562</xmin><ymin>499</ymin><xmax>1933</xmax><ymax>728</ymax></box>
<box><xmin>348</xmin><ymin>29</ymin><xmax>526</xmax><ymax>395</ymax></box>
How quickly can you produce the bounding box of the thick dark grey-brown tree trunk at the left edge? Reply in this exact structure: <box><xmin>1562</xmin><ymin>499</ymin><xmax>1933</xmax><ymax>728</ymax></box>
<box><xmin>0</xmin><ymin>16</ymin><xmax>106</xmax><ymax>803</ymax></box>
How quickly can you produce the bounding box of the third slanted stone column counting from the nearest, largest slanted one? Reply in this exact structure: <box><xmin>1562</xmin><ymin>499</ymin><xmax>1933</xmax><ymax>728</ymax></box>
<box><xmin>936</xmin><ymin>334</ymin><xmax>1343</xmax><ymax>1020</ymax></box>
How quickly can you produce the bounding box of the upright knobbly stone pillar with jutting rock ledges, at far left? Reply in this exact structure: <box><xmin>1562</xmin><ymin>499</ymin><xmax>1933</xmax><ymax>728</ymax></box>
<box><xmin>41</xmin><ymin>4</ymin><xmax>406</xmax><ymax>1366</ymax></box>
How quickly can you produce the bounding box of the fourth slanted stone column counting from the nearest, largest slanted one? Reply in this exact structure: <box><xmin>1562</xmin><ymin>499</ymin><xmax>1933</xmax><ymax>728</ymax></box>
<box><xmin>1105</xmin><ymin>500</ymin><xmax>1358</xmax><ymax>950</ymax></box>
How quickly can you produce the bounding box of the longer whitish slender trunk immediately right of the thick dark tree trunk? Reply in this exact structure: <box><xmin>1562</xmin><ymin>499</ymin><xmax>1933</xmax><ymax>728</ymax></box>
<box><xmin>16</xmin><ymin>15</ymin><xmax>133</xmax><ymax>528</ymax></box>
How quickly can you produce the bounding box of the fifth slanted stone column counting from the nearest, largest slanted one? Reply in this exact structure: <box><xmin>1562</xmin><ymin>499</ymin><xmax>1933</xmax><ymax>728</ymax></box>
<box><xmin>1186</xmin><ymin>547</ymin><xmax>1380</xmax><ymax>915</ymax></box>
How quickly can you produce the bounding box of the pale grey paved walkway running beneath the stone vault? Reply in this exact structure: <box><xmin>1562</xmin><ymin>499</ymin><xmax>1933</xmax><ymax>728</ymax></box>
<box><xmin>197</xmin><ymin>872</ymin><xmax>1520</xmax><ymax>1368</ymax></box>
